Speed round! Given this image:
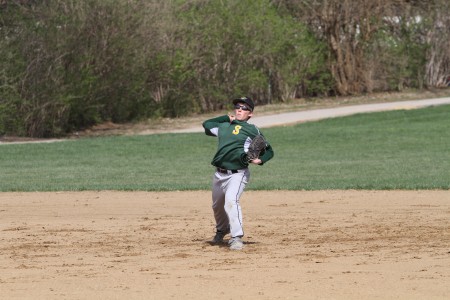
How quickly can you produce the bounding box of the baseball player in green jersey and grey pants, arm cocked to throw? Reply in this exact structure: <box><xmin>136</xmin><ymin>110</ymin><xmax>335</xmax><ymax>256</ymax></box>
<box><xmin>203</xmin><ymin>97</ymin><xmax>274</xmax><ymax>250</ymax></box>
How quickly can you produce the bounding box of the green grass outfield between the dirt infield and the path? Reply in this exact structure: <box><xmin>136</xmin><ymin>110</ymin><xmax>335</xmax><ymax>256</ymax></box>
<box><xmin>0</xmin><ymin>105</ymin><xmax>450</xmax><ymax>191</ymax></box>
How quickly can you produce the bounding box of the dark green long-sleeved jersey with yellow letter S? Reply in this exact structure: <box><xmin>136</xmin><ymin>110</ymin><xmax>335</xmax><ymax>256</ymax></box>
<box><xmin>203</xmin><ymin>115</ymin><xmax>274</xmax><ymax>170</ymax></box>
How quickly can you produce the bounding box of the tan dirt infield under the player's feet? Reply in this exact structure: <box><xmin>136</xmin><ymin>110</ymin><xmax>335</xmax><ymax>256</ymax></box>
<box><xmin>0</xmin><ymin>191</ymin><xmax>450</xmax><ymax>299</ymax></box>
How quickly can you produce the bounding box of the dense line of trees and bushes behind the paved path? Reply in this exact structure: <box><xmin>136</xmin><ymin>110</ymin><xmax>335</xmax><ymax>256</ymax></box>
<box><xmin>0</xmin><ymin>0</ymin><xmax>450</xmax><ymax>137</ymax></box>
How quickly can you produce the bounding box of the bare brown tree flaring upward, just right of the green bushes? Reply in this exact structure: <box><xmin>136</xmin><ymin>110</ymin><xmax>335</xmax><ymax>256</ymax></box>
<box><xmin>278</xmin><ymin>0</ymin><xmax>401</xmax><ymax>95</ymax></box>
